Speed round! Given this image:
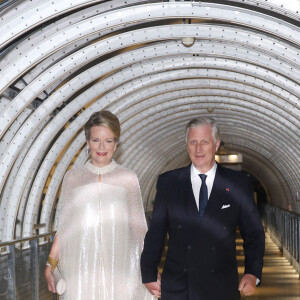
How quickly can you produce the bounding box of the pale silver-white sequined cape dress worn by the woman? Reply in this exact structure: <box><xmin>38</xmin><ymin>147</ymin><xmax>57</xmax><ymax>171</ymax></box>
<box><xmin>57</xmin><ymin>161</ymin><xmax>154</xmax><ymax>300</ymax></box>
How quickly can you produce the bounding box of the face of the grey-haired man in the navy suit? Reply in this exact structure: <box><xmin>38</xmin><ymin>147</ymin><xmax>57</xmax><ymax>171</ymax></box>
<box><xmin>187</xmin><ymin>125</ymin><xmax>220</xmax><ymax>173</ymax></box>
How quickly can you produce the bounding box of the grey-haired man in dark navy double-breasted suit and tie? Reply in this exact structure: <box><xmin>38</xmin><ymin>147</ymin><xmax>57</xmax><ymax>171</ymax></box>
<box><xmin>141</xmin><ymin>117</ymin><xmax>265</xmax><ymax>300</ymax></box>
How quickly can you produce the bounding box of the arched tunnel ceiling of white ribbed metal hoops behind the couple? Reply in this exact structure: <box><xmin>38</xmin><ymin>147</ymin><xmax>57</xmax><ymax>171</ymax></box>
<box><xmin>0</xmin><ymin>0</ymin><xmax>300</xmax><ymax>241</ymax></box>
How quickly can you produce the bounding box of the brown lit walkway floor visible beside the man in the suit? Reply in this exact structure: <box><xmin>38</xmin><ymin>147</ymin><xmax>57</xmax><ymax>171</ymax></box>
<box><xmin>237</xmin><ymin>233</ymin><xmax>300</xmax><ymax>300</ymax></box>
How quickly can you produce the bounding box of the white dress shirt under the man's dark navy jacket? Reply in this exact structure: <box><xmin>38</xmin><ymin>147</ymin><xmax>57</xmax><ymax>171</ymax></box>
<box><xmin>191</xmin><ymin>163</ymin><xmax>217</xmax><ymax>210</ymax></box>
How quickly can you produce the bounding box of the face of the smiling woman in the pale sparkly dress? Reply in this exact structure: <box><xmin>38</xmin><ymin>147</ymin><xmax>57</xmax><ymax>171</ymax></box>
<box><xmin>87</xmin><ymin>126</ymin><xmax>117</xmax><ymax>168</ymax></box>
